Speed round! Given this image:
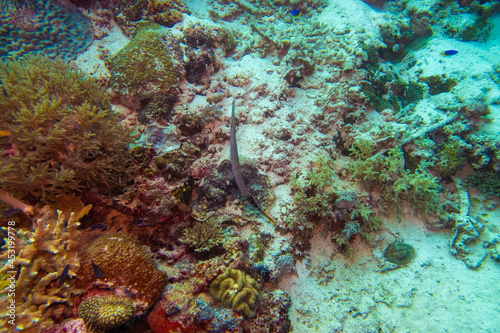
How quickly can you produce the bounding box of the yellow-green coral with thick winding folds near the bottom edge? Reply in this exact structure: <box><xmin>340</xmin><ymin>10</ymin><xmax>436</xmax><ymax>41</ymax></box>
<box><xmin>210</xmin><ymin>268</ymin><xmax>262</xmax><ymax>318</ymax></box>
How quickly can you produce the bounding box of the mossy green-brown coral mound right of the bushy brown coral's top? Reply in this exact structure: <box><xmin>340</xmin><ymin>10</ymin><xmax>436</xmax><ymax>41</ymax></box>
<box><xmin>108</xmin><ymin>29</ymin><xmax>179</xmax><ymax>93</ymax></box>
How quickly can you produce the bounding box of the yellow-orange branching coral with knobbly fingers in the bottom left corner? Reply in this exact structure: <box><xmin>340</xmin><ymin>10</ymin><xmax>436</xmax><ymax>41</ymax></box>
<box><xmin>0</xmin><ymin>206</ymin><xmax>85</xmax><ymax>332</ymax></box>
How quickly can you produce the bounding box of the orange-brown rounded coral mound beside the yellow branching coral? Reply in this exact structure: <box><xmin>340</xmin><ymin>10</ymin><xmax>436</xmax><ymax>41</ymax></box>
<box><xmin>82</xmin><ymin>233</ymin><xmax>167</xmax><ymax>311</ymax></box>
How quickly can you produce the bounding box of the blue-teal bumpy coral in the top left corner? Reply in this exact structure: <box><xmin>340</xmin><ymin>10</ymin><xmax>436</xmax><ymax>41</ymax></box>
<box><xmin>0</xmin><ymin>0</ymin><xmax>93</xmax><ymax>59</ymax></box>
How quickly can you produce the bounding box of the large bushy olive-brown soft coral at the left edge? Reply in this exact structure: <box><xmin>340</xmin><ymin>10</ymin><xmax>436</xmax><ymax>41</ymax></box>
<box><xmin>0</xmin><ymin>56</ymin><xmax>135</xmax><ymax>201</ymax></box>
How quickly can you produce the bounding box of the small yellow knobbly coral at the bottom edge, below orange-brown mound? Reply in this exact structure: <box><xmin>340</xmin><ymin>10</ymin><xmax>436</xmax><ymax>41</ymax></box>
<box><xmin>78</xmin><ymin>295</ymin><xmax>135</xmax><ymax>333</ymax></box>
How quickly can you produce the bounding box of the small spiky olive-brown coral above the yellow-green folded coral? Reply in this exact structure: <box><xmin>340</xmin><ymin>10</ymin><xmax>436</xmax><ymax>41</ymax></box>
<box><xmin>180</xmin><ymin>220</ymin><xmax>224</xmax><ymax>252</ymax></box>
